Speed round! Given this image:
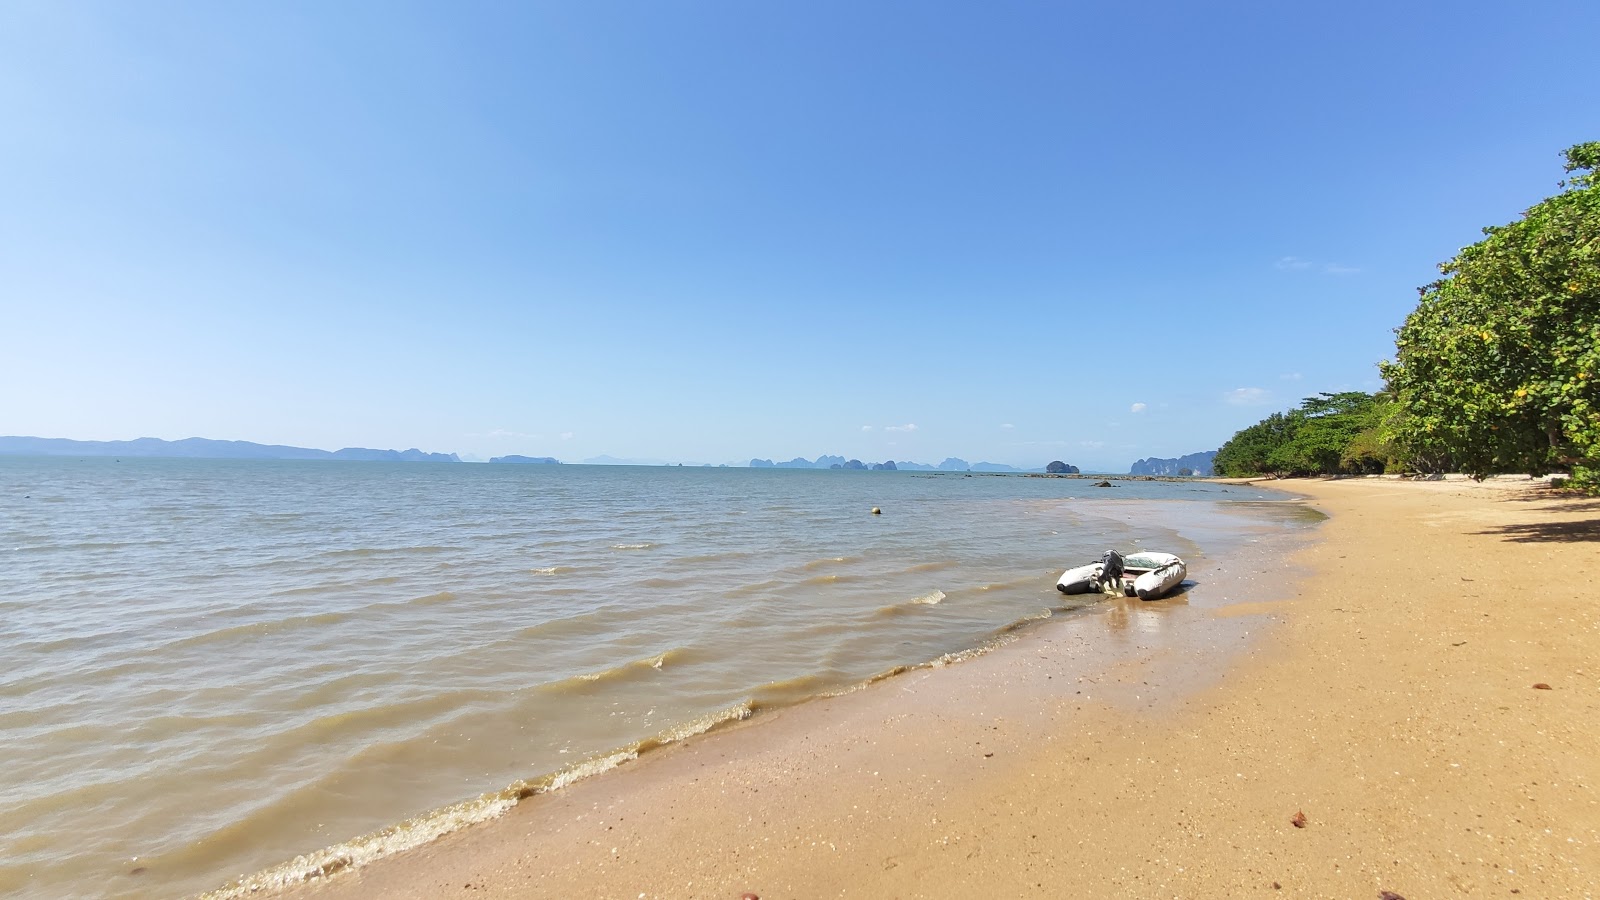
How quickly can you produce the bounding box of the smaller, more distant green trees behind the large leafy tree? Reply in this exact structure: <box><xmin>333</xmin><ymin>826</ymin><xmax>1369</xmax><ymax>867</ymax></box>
<box><xmin>1211</xmin><ymin>391</ymin><xmax>1389</xmax><ymax>477</ymax></box>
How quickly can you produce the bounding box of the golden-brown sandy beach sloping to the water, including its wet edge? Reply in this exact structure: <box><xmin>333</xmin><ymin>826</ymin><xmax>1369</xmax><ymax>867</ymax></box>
<box><xmin>281</xmin><ymin>479</ymin><xmax>1600</xmax><ymax>900</ymax></box>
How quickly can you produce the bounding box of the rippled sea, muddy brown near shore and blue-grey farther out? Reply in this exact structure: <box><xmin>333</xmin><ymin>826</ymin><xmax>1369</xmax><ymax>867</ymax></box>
<box><xmin>0</xmin><ymin>456</ymin><xmax>1299</xmax><ymax>898</ymax></box>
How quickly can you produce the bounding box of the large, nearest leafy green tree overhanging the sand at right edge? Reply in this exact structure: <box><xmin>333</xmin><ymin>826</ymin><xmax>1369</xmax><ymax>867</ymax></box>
<box><xmin>1381</xmin><ymin>141</ymin><xmax>1600</xmax><ymax>487</ymax></box>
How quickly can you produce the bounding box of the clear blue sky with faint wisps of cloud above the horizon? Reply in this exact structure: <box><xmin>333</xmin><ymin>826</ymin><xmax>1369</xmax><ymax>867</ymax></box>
<box><xmin>0</xmin><ymin>0</ymin><xmax>1600</xmax><ymax>471</ymax></box>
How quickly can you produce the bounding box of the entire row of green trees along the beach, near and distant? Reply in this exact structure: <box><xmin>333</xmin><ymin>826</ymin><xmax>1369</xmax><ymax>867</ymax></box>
<box><xmin>1216</xmin><ymin>141</ymin><xmax>1600</xmax><ymax>492</ymax></box>
